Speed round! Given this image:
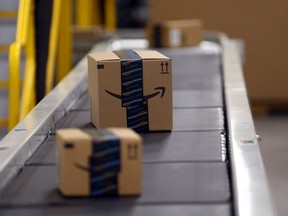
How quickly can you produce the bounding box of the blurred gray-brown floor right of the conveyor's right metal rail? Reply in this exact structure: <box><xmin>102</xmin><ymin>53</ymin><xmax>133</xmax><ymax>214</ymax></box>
<box><xmin>254</xmin><ymin>113</ymin><xmax>288</xmax><ymax>216</ymax></box>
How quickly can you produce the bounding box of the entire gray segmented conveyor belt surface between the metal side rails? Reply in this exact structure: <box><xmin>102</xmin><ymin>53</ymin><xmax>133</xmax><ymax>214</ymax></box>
<box><xmin>0</xmin><ymin>40</ymin><xmax>231</xmax><ymax>216</ymax></box>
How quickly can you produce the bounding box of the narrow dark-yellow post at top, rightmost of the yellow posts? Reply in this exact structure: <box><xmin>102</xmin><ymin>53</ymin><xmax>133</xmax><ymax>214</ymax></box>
<box><xmin>105</xmin><ymin>0</ymin><xmax>116</xmax><ymax>31</ymax></box>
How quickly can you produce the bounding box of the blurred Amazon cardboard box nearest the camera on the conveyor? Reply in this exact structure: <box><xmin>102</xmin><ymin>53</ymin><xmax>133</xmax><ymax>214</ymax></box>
<box><xmin>56</xmin><ymin>128</ymin><xmax>142</xmax><ymax>197</ymax></box>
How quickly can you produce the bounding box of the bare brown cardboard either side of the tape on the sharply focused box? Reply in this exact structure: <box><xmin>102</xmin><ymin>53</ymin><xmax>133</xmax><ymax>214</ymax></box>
<box><xmin>88</xmin><ymin>50</ymin><xmax>172</xmax><ymax>131</ymax></box>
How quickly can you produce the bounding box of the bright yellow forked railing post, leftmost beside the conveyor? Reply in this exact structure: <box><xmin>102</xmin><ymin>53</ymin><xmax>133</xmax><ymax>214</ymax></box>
<box><xmin>8</xmin><ymin>0</ymin><xmax>36</xmax><ymax>129</ymax></box>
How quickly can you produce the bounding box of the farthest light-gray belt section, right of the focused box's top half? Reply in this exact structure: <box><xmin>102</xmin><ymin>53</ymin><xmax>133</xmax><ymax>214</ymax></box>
<box><xmin>165</xmin><ymin>46</ymin><xmax>222</xmax><ymax>90</ymax></box>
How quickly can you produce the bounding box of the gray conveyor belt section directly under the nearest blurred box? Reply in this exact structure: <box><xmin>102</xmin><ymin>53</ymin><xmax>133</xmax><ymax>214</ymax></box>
<box><xmin>0</xmin><ymin>162</ymin><xmax>231</xmax><ymax>207</ymax></box>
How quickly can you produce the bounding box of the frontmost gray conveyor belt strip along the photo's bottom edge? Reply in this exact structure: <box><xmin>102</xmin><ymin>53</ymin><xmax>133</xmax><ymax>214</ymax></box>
<box><xmin>1</xmin><ymin>204</ymin><xmax>232</xmax><ymax>216</ymax></box>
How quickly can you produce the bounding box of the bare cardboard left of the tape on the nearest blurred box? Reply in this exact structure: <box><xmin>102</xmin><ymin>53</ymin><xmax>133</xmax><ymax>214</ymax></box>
<box><xmin>56</xmin><ymin>129</ymin><xmax>92</xmax><ymax>196</ymax></box>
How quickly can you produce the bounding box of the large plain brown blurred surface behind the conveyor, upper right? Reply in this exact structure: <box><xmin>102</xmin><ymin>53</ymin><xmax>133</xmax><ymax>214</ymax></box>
<box><xmin>150</xmin><ymin>0</ymin><xmax>288</xmax><ymax>103</ymax></box>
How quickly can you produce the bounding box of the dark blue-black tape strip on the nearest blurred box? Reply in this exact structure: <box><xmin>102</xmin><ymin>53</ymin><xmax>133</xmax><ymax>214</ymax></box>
<box><xmin>85</xmin><ymin>129</ymin><xmax>121</xmax><ymax>197</ymax></box>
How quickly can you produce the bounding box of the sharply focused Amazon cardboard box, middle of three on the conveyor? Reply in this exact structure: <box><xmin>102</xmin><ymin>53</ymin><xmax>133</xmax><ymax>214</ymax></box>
<box><xmin>88</xmin><ymin>50</ymin><xmax>173</xmax><ymax>132</ymax></box>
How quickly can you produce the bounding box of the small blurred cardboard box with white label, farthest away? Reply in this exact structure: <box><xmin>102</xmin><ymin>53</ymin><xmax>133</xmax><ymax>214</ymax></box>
<box><xmin>146</xmin><ymin>19</ymin><xmax>203</xmax><ymax>47</ymax></box>
